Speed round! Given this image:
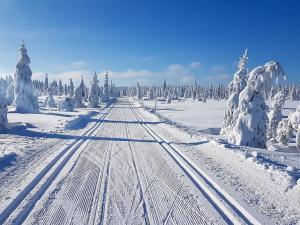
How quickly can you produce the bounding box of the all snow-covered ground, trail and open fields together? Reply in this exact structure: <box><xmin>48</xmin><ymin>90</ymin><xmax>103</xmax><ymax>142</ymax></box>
<box><xmin>0</xmin><ymin>98</ymin><xmax>300</xmax><ymax>224</ymax></box>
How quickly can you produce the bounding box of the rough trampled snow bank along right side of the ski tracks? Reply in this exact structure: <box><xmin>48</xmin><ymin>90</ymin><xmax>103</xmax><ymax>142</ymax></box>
<box><xmin>140</xmin><ymin>102</ymin><xmax>300</xmax><ymax>224</ymax></box>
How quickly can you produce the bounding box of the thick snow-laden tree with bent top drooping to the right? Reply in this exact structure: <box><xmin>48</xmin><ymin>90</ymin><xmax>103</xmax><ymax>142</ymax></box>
<box><xmin>228</xmin><ymin>61</ymin><xmax>286</xmax><ymax>148</ymax></box>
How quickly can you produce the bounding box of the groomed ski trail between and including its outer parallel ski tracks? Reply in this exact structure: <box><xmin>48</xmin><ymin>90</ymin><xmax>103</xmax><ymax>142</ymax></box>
<box><xmin>0</xmin><ymin>99</ymin><xmax>258</xmax><ymax>225</ymax></box>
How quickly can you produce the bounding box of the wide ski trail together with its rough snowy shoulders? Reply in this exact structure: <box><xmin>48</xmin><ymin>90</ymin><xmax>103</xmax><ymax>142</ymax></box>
<box><xmin>0</xmin><ymin>99</ymin><xmax>300</xmax><ymax>224</ymax></box>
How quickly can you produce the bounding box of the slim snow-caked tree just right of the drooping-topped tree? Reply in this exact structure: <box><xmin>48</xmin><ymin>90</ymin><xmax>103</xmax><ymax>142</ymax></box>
<box><xmin>267</xmin><ymin>91</ymin><xmax>285</xmax><ymax>141</ymax></box>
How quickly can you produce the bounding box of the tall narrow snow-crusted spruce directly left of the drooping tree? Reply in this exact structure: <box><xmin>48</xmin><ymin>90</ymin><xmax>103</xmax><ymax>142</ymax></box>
<box><xmin>220</xmin><ymin>49</ymin><xmax>248</xmax><ymax>135</ymax></box>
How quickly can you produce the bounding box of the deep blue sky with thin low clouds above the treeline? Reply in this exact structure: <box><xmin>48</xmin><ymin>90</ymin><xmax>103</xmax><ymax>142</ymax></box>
<box><xmin>0</xmin><ymin>0</ymin><xmax>300</xmax><ymax>85</ymax></box>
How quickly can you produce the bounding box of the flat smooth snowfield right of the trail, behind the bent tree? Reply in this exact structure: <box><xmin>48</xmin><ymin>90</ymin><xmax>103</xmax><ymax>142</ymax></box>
<box><xmin>141</xmin><ymin>98</ymin><xmax>300</xmax><ymax>135</ymax></box>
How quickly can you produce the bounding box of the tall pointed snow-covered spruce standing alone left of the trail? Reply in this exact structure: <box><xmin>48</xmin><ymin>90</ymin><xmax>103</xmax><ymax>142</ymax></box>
<box><xmin>14</xmin><ymin>41</ymin><xmax>39</xmax><ymax>113</ymax></box>
